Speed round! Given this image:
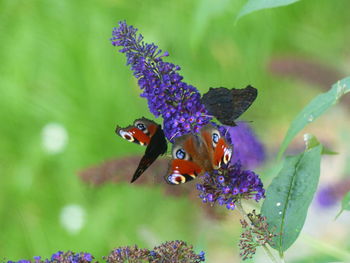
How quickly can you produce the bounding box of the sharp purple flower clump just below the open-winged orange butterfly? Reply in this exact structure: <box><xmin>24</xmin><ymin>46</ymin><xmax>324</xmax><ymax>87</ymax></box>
<box><xmin>197</xmin><ymin>162</ymin><xmax>265</xmax><ymax>210</ymax></box>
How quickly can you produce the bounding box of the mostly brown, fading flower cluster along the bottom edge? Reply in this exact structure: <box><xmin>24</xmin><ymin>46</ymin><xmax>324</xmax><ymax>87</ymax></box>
<box><xmin>105</xmin><ymin>240</ymin><xmax>205</xmax><ymax>263</ymax></box>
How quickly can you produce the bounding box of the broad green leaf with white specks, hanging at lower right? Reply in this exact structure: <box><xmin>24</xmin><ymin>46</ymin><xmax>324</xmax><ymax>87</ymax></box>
<box><xmin>261</xmin><ymin>144</ymin><xmax>322</xmax><ymax>255</ymax></box>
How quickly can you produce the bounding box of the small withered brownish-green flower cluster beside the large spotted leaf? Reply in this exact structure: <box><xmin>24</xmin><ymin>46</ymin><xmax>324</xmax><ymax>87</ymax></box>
<box><xmin>239</xmin><ymin>210</ymin><xmax>276</xmax><ymax>260</ymax></box>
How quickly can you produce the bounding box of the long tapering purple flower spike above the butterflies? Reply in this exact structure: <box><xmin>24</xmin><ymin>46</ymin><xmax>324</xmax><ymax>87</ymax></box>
<box><xmin>111</xmin><ymin>21</ymin><xmax>211</xmax><ymax>141</ymax></box>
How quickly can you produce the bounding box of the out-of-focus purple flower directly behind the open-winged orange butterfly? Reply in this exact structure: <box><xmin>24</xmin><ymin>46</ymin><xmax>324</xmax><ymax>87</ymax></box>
<box><xmin>219</xmin><ymin>122</ymin><xmax>266</xmax><ymax>169</ymax></box>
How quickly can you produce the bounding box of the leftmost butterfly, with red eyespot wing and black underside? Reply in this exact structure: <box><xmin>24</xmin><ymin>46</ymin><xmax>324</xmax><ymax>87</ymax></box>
<box><xmin>116</xmin><ymin>118</ymin><xmax>167</xmax><ymax>183</ymax></box>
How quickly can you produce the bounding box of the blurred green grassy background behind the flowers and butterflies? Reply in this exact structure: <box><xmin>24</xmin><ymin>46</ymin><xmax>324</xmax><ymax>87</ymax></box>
<box><xmin>0</xmin><ymin>0</ymin><xmax>350</xmax><ymax>262</ymax></box>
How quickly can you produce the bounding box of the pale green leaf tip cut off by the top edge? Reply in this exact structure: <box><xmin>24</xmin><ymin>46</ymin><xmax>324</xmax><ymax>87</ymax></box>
<box><xmin>236</xmin><ymin>0</ymin><xmax>299</xmax><ymax>22</ymax></box>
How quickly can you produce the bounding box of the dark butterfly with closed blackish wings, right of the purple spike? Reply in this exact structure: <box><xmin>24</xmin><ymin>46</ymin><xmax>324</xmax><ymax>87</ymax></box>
<box><xmin>201</xmin><ymin>86</ymin><xmax>258</xmax><ymax>126</ymax></box>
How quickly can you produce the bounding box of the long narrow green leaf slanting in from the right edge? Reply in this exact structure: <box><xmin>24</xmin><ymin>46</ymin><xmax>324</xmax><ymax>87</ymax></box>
<box><xmin>278</xmin><ymin>77</ymin><xmax>350</xmax><ymax>159</ymax></box>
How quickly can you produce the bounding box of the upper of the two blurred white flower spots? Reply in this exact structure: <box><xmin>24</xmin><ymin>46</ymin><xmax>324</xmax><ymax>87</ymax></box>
<box><xmin>41</xmin><ymin>123</ymin><xmax>68</xmax><ymax>154</ymax></box>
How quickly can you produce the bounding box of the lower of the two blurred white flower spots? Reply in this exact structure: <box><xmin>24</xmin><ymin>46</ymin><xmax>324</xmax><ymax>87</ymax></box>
<box><xmin>60</xmin><ymin>204</ymin><xmax>86</xmax><ymax>234</ymax></box>
